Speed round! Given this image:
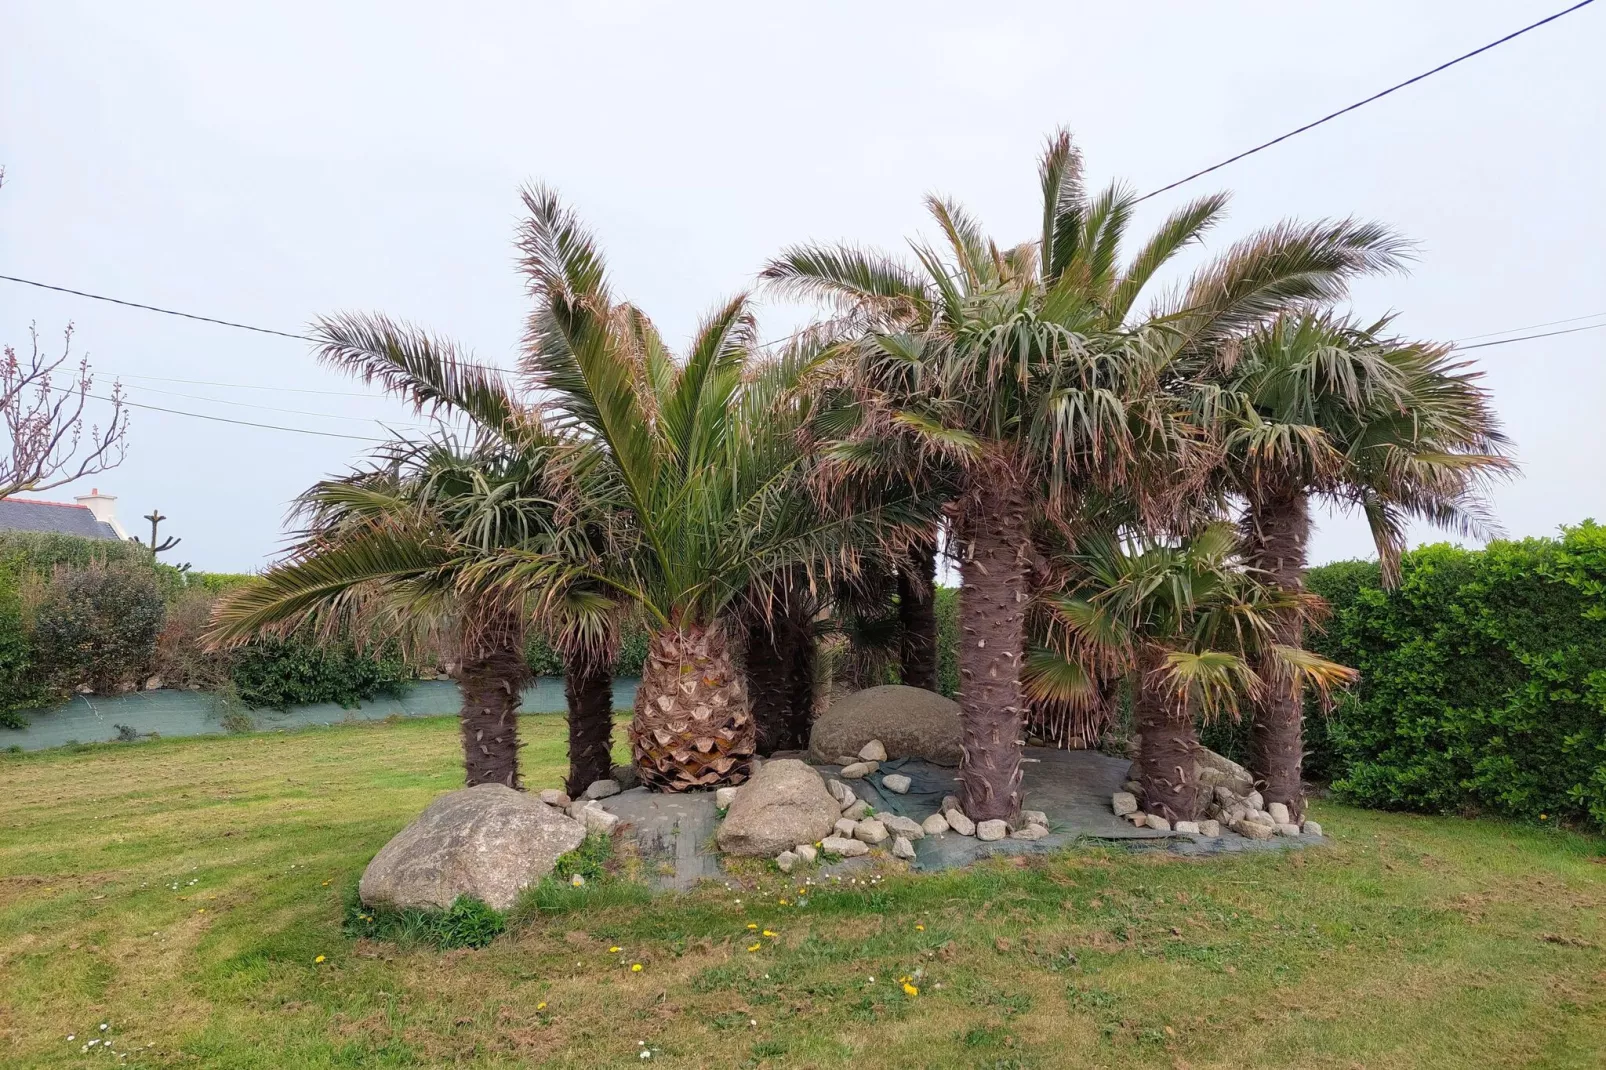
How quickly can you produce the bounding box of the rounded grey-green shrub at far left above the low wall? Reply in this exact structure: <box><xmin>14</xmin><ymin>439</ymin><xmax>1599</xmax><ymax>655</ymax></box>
<box><xmin>34</xmin><ymin>561</ymin><xmax>165</xmax><ymax>694</ymax></box>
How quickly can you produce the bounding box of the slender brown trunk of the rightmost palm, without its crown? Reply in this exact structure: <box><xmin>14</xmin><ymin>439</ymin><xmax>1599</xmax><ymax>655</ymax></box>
<box><xmin>1246</xmin><ymin>493</ymin><xmax>1310</xmax><ymax>823</ymax></box>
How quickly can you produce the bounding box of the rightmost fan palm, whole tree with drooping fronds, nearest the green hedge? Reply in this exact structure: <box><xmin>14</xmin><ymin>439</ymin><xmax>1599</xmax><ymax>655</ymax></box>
<box><xmin>1206</xmin><ymin>313</ymin><xmax>1513</xmax><ymax>816</ymax></box>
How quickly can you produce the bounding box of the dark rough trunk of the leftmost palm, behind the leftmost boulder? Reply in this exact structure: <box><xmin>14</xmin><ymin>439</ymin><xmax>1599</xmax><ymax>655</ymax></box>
<box><xmin>458</xmin><ymin>607</ymin><xmax>530</xmax><ymax>789</ymax></box>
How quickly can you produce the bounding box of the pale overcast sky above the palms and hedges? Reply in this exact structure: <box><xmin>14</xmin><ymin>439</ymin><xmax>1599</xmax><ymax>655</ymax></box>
<box><xmin>0</xmin><ymin>0</ymin><xmax>1606</xmax><ymax>570</ymax></box>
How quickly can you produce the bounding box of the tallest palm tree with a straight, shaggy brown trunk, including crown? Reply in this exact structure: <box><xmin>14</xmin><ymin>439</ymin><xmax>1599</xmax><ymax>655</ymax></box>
<box><xmin>763</xmin><ymin>132</ymin><xmax>1400</xmax><ymax>819</ymax></box>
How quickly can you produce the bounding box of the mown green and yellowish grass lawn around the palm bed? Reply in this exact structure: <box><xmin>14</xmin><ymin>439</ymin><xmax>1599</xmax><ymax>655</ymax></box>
<box><xmin>0</xmin><ymin>717</ymin><xmax>1606</xmax><ymax>1070</ymax></box>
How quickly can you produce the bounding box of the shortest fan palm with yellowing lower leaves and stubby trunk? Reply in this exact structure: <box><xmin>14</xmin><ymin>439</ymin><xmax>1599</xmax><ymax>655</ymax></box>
<box><xmin>1029</xmin><ymin>524</ymin><xmax>1355</xmax><ymax>821</ymax></box>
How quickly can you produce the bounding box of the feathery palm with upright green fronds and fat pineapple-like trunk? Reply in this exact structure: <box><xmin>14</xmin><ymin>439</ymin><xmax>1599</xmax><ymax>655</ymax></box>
<box><xmin>512</xmin><ymin>188</ymin><xmax>931</xmax><ymax>790</ymax></box>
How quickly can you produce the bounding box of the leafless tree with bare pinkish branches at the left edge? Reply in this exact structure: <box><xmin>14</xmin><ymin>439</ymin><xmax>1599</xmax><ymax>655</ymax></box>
<box><xmin>0</xmin><ymin>325</ymin><xmax>128</xmax><ymax>496</ymax></box>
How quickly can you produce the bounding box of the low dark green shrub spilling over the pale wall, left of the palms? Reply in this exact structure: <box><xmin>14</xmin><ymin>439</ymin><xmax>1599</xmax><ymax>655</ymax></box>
<box><xmin>230</xmin><ymin>636</ymin><xmax>411</xmax><ymax>710</ymax></box>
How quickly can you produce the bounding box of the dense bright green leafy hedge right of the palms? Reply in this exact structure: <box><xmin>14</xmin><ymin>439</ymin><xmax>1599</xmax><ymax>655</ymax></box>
<box><xmin>1307</xmin><ymin>522</ymin><xmax>1606</xmax><ymax>826</ymax></box>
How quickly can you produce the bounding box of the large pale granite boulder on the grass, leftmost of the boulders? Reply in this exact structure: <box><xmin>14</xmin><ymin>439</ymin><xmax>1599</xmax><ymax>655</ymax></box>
<box><xmin>357</xmin><ymin>784</ymin><xmax>586</xmax><ymax>911</ymax></box>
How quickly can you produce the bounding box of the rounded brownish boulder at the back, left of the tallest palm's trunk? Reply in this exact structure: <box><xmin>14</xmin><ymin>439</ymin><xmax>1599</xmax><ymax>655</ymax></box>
<box><xmin>808</xmin><ymin>684</ymin><xmax>962</xmax><ymax>765</ymax></box>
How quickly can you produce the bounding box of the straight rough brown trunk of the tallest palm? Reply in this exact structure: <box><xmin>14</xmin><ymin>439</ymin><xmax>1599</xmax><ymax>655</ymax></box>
<box><xmin>957</xmin><ymin>474</ymin><xmax>1029</xmax><ymax>821</ymax></box>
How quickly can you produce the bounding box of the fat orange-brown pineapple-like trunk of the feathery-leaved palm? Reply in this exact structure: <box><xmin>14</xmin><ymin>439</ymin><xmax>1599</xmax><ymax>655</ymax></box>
<box><xmin>630</xmin><ymin>623</ymin><xmax>756</xmax><ymax>792</ymax></box>
